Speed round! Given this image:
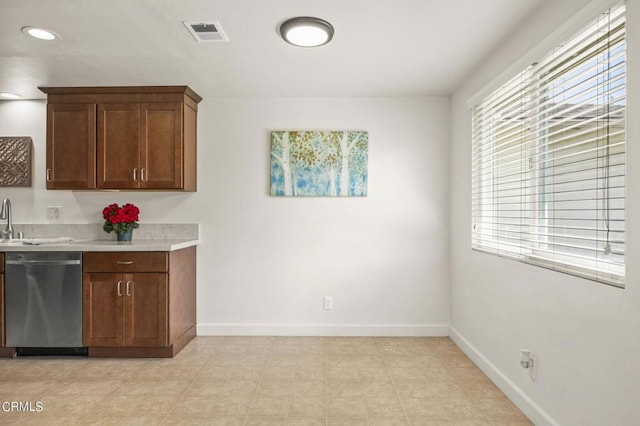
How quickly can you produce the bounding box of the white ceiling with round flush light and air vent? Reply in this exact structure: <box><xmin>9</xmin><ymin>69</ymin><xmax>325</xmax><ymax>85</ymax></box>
<box><xmin>0</xmin><ymin>0</ymin><xmax>546</xmax><ymax>98</ymax></box>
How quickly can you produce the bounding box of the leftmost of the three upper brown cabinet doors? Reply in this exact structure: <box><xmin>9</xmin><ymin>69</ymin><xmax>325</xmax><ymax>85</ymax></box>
<box><xmin>46</xmin><ymin>104</ymin><xmax>96</xmax><ymax>189</ymax></box>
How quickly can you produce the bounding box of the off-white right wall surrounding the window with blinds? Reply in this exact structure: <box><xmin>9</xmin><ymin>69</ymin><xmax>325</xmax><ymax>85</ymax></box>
<box><xmin>450</xmin><ymin>0</ymin><xmax>640</xmax><ymax>425</ymax></box>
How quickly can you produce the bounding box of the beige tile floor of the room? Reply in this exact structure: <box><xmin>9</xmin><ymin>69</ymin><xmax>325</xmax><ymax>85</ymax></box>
<box><xmin>0</xmin><ymin>337</ymin><xmax>532</xmax><ymax>426</ymax></box>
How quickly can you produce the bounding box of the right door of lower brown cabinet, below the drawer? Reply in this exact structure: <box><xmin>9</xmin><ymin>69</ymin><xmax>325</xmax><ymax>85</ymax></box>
<box><xmin>125</xmin><ymin>273</ymin><xmax>169</xmax><ymax>346</ymax></box>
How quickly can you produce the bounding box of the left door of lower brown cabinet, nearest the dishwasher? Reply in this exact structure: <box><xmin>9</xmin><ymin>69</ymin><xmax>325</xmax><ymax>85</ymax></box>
<box><xmin>82</xmin><ymin>273</ymin><xmax>125</xmax><ymax>346</ymax></box>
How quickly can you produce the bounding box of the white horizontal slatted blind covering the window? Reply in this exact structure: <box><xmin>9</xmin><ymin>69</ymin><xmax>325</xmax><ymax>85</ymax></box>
<box><xmin>472</xmin><ymin>5</ymin><xmax>626</xmax><ymax>287</ymax></box>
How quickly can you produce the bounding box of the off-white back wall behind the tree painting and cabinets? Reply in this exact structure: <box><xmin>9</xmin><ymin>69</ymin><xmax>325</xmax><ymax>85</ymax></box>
<box><xmin>0</xmin><ymin>98</ymin><xmax>449</xmax><ymax>335</ymax></box>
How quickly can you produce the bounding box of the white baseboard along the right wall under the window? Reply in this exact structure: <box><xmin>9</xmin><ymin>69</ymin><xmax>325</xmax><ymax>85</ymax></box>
<box><xmin>449</xmin><ymin>326</ymin><xmax>558</xmax><ymax>426</ymax></box>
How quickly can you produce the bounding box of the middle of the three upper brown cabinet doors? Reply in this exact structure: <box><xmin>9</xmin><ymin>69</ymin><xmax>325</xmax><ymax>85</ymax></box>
<box><xmin>98</xmin><ymin>103</ymin><xmax>140</xmax><ymax>189</ymax></box>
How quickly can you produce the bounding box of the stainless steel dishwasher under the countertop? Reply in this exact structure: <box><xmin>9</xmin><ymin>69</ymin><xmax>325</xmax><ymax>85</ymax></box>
<box><xmin>5</xmin><ymin>251</ymin><xmax>82</xmax><ymax>348</ymax></box>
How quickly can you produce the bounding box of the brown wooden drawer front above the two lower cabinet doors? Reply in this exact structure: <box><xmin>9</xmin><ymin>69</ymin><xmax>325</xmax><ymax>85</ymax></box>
<box><xmin>82</xmin><ymin>251</ymin><xmax>169</xmax><ymax>272</ymax></box>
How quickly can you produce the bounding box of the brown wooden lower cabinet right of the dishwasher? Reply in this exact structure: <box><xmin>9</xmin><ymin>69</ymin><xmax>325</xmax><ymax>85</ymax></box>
<box><xmin>82</xmin><ymin>247</ymin><xmax>196</xmax><ymax>357</ymax></box>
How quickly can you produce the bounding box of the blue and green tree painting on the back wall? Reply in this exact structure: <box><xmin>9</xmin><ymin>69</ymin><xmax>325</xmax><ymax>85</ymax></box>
<box><xmin>271</xmin><ymin>131</ymin><xmax>369</xmax><ymax>197</ymax></box>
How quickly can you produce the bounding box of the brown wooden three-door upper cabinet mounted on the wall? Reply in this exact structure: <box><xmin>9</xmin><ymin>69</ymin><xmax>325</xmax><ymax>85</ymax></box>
<box><xmin>40</xmin><ymin>86</ymin><xmax>202</xmax><ymax>191</ymax></box>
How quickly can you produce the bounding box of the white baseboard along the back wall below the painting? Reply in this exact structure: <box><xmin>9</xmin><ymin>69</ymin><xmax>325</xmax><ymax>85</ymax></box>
<box><xmin>196</xmin><ymin>323</ymin><xmax>449</xmax><ymax>337</ymax></box>
